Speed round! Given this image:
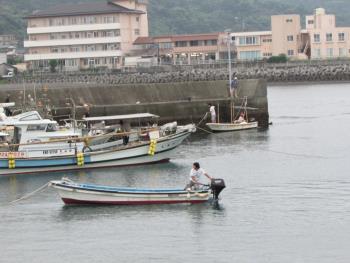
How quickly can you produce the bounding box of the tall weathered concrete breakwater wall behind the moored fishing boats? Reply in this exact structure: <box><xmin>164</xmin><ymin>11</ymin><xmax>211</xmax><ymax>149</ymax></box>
<box><xmin>0</xmin><ymin>80</ymin><xmax>268</xmax><ymax>126</ymax></box>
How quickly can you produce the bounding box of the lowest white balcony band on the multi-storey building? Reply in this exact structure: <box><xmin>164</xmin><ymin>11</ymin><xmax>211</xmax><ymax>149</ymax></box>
<box><xmin>24</xmin><ymin>50</ymin><xmax>123</xmax><ymax>61</ymax></box>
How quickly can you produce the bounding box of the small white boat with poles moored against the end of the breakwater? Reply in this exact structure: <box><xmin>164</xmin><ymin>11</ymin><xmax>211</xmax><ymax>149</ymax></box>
<box><xmin>206</xmin><ymin>97</ymin><xmax>258</xmax><ymax>132</ymax></box>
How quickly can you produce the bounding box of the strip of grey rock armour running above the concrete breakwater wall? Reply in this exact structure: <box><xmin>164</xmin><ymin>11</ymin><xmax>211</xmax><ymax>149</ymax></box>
<box><xmin>11</xmin><ymin>63</ymin><xmax>350</xmax><ymax>84</ymax></box>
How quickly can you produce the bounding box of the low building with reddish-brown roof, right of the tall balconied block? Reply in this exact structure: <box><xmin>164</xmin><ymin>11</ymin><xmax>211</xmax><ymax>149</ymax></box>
<box><xmin>130</xmin><ymin>33</ymin><xmax>227</xmax><ymax>65</ymax></box>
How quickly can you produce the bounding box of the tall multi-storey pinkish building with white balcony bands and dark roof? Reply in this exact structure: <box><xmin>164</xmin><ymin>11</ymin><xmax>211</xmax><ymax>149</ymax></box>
<box><xmin>24</xmin><ymin>0</ymin><xmax>148</xmax><ymax>70</ymax></box>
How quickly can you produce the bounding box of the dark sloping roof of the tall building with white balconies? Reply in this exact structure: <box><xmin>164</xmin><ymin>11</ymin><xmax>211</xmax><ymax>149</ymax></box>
<box><xmin>26</xmin><ymin>1</ymin><xmax>144</xmax><ymax>18</ymax></box>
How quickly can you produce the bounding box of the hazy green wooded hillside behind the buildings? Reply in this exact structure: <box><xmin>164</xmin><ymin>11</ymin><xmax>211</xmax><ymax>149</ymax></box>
<box><xmin>0</xmin><ymin>0</ymin><xmax>350</xmax><ymax>38</ymax></box>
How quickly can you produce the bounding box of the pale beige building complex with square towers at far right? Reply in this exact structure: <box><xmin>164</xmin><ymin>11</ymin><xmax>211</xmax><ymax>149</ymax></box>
<box><xmin>232</xmin><ymin>8</ymin><xmax>350</xmax><ymax>60</ymax></box>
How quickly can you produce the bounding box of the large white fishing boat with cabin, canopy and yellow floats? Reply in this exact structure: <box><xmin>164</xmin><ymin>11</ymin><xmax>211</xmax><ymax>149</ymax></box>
<box><xmin>0</xmin><ymin>112</ymin><xmax>195</xmax><ymax>175</ymax></box>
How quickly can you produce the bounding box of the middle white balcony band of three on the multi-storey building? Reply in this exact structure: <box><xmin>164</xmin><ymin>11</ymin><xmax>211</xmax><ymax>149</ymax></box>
<box><xmin>24</xmin><ymin>37</ymin><xmax>121</xmax><ymax>48</ymax></box>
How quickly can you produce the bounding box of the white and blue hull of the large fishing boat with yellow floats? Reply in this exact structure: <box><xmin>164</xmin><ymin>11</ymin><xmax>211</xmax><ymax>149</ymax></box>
<box><xmin>0</xmin><ymin>132</ymin><xmax>191</xmax><ymax>175</ymax></box>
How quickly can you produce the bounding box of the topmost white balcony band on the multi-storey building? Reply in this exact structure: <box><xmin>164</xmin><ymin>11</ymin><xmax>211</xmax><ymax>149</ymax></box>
<box><xmin>27</xmin><ymin>23</ymin><xmax>120</xmax><ymax>35</ymax></box>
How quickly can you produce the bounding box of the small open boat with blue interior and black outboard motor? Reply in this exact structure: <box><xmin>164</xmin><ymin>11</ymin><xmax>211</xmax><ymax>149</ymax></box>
<box><xmin>49</xmin><ymin>178</ymin><xmax>225</xmax><ymax>205</ymax></box>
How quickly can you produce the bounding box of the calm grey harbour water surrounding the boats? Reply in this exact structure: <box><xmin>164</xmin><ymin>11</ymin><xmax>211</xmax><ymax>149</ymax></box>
<box><xmin>0</xmin><ymin>84</ymin><xmax>350</xmax><ymax>263</ymax></box>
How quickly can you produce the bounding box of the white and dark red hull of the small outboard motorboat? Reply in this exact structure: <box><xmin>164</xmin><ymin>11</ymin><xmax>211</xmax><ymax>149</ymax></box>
<box><xmin>50</xmin><ymin>181</ymin><xmax>211</xmax><ymax>205</ymax></box>
